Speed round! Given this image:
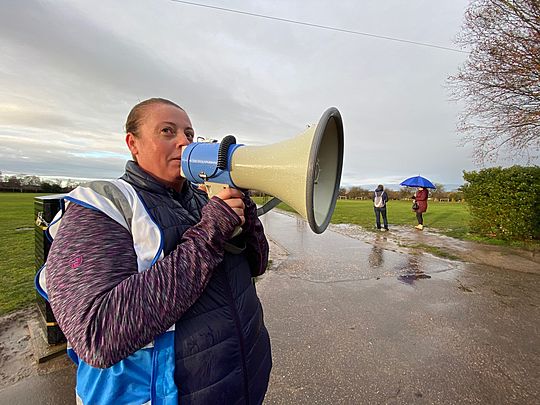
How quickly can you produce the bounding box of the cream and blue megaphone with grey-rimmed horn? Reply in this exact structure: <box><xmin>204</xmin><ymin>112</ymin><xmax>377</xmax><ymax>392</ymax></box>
<box><xmin>181</xmin><ymin>107</ymin><xmax>343</xmax><ymax>233</ymax></box>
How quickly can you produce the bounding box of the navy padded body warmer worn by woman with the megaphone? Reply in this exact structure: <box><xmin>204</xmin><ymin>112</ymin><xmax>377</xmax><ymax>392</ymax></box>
<box><xmin>123</xmin><ymin>162</ymin><xmax>272</xmax><ymax>404</ymax></box>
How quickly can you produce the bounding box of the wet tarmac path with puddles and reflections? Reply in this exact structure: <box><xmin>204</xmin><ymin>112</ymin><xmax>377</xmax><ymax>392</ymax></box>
<box><xmin>0</xmin><ymin>211</ymin><xmax>540</xmax><ymax>405</ymax></box>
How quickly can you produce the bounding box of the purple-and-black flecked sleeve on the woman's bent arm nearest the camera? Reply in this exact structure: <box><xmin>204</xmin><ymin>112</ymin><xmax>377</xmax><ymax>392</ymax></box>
<box><xmin>47</xmin><ymin>198</ymin><xmax>243</xmax><ymax>368</ymax></box>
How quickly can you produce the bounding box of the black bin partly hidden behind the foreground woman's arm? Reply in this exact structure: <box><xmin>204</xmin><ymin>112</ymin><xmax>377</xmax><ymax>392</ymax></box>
<box><xmin>34</xmin><ymin>194</ymin><xmax>66</xmax><ymax>345</ymax></box>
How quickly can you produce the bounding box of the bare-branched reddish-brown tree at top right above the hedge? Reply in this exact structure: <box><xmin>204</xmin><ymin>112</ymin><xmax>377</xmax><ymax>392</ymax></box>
<box><xmin>449</xmin><ymin>0</ymin><xmax>540</xmax><ymax>163</ymax></box>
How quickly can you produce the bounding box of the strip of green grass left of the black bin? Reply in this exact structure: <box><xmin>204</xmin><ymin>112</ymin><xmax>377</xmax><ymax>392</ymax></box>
<box><xmin>0</xmin><ymin>193</ymin><xmax>45</xmax><ymax>315</ymax></box>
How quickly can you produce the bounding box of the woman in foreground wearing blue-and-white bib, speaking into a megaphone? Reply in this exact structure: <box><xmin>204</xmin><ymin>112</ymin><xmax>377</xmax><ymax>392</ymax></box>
<box><xmin>41</xmin><ymin>98</ymin><xmax>271</xmax><ymax>404</ymax></box>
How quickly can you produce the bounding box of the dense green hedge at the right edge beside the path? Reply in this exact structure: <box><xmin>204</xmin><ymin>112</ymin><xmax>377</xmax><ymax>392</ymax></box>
<box><xmin>463</xmin><ymin>166</ymin><xmax>540</xmax><ymax>240</ymax></box>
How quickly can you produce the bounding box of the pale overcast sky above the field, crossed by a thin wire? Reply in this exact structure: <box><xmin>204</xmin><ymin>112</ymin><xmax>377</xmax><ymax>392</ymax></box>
<box><xmin>0</xmin><ymin>0</ymin><xmax>532</xmax><ymax>186</ymax></box>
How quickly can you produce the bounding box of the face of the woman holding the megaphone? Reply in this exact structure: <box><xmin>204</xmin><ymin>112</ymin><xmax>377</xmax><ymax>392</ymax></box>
<box><xmin>126</xmin><ymin>104</ymin><xmax>195</xmax><ymax>191</ymax></box>
